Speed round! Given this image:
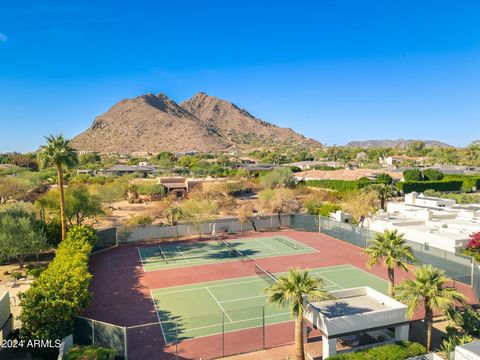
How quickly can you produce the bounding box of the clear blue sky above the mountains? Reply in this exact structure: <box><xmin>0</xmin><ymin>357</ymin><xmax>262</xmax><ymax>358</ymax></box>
<box><xmin>0</xmin><ymin>0</ymin><xmax>480</xmax><ymax>152</ymax></box>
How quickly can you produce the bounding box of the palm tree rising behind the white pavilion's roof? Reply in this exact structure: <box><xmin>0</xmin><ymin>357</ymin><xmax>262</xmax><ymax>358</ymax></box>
<box><xmin>364</xmin><ymin>230</ymin><xmax>415</xmax><ymax>296</ymax></box>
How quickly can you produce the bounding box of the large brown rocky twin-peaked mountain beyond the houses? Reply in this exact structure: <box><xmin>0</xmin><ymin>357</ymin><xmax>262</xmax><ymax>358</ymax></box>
<box><xmin>72</xmin><ymin>93</ymin><xmax>321</xmax><ymax>153</ymax></box>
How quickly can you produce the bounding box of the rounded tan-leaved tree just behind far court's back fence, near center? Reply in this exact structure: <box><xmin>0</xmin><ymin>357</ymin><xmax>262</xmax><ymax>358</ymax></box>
<box><xmin>258</xmin><ymin>189</ymin><xmax>300</xmax><ymax>226</ymax></box>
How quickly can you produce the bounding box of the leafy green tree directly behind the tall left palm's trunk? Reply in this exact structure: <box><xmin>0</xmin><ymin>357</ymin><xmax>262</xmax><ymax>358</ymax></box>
<box><xmin>37</xmin><ymin>186</ymin><xmax>104</xmax><ymax>226</ymax></box>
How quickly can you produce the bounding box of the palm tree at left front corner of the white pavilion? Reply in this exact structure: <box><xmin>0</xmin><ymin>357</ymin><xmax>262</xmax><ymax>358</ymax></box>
<box><xmin>265</xmin><ymin>268</ymin><xmax>333</xmax><ymax>360</ymax></box>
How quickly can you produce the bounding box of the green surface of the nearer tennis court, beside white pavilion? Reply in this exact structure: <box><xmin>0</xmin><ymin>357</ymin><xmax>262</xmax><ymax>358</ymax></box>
<box><xmin>152</xmin><ymin>265</ymin><xmax>387</xmax><ymax>343</ymax></box>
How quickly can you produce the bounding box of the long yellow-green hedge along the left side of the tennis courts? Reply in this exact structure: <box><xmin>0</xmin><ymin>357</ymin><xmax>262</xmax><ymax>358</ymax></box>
<box><xmin>20</xmin><ymin>226</ymin><xmax>97</xmax><ymax>341</ymax></box>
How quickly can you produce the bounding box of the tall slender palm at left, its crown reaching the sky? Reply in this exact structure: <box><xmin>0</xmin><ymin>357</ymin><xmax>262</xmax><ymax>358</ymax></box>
<box><xmin>38</xmin><ymin>135</ymin><xmax>78</xmax><ymax>240</ymax></box>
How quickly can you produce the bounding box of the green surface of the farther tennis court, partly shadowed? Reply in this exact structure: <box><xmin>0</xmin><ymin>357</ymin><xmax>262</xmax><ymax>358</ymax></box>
<box><xmin>138</xmin><ymin>235</ymin><xmax>317</xmax><ymax>271</ymax></box>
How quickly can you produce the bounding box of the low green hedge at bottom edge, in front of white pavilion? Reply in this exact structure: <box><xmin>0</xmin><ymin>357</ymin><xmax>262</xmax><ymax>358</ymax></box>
<box><xmin>329</xmin><ymin>341</ymin><xmax>427</xmax><ymax>360</ymax></box>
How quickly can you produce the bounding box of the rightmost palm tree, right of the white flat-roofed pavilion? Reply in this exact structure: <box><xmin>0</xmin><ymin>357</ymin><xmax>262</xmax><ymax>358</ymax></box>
<box><xmin>395</xmin><ymin>265</ymin><xmax>465</xmax><ymax>351</ymax></box>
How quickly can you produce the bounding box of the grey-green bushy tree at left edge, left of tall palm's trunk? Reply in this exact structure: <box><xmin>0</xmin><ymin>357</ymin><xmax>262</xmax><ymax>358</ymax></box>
<box><xmin>0</xmin><ymin>203</ymin><xmax>48</xmax><ymax>269</ymax></box>
